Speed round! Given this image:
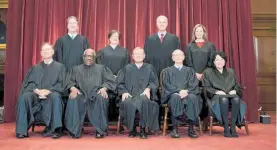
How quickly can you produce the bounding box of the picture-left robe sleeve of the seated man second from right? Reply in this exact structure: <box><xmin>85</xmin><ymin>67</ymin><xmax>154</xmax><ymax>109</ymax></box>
<box><xmin>161</xmin><ymin>68</ymin><xmax>182</xmax><ymax>98</ymax></box>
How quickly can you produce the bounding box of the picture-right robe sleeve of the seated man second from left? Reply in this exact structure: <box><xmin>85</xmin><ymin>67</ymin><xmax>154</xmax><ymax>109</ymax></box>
<box><xmin>101</xmin><ymin>66</ymin><xmax>116</xmax><ymax>92</ymax></box>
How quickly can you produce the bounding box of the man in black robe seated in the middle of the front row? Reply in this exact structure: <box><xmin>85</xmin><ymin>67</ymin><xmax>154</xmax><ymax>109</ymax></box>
<box><xmin>117</xmin><ymin>48</ymin><xmax>159</xmax><ymax>139</ymax></box>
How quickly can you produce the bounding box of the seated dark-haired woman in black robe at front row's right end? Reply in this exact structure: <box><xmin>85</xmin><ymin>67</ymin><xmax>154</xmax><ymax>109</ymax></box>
<box><xmin>203</xmin><ymin>51</ymin><xmax>246</xmax><ymax>137</ymax></box>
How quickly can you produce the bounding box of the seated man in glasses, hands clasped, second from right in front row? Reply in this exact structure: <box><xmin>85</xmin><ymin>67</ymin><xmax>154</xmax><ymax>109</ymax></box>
<box><xmin>162</xmin><ymin>50</ymin><xmax>202</xmax><ymax>138</ymax></box>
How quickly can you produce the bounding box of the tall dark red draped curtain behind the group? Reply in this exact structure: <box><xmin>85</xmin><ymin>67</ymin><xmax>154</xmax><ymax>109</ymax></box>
<box><xmin>4</xmin><ymin>0</ymin><xmax>258</xmax><ymax>122</ymax></box>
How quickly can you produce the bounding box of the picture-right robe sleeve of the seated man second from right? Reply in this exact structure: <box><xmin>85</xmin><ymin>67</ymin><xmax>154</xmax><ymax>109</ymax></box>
<box><xmin>185</xmin><ymin>68</ymin><xmax>199</xmax><ymax>94</ymax></box>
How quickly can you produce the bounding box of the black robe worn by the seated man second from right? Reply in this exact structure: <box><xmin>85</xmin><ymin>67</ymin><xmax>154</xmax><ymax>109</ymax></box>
<box><xmin>162</xmin><ymin>66</ymin><xmax>202</xmax><ymax>121</ymax></box>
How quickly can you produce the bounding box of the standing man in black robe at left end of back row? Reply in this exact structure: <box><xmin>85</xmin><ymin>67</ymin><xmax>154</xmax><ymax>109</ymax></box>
<box><xmin>54</xmin><ymin>16</ymin><xmax>90</xmax><ymax>71</ymax></box>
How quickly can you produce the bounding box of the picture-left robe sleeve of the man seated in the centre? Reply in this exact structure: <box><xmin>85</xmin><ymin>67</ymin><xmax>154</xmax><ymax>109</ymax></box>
<box><xmin>116</xmin><ymin>68</ymin><xmax>129</xmax><ymax>96</ymax></box>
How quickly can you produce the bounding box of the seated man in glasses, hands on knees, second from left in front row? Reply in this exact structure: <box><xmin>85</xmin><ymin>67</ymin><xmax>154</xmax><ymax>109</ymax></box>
<box><xmin>65</xmin><ymin>49</ymin><xmax>116</xmax><ymax>138</ymax></box>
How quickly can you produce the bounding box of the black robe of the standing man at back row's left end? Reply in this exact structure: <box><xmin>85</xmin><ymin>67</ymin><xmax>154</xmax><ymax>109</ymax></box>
<box><xmin>54</xmin><ymin>34</ymin><xmax>90</xmax><ymax>71</ymax></box>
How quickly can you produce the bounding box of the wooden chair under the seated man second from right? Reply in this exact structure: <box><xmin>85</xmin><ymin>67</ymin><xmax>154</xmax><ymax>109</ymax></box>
<box><xmin>159</xmin><ymin>68</ymin><xmax>202</xmax><ymax>136</ymax></box>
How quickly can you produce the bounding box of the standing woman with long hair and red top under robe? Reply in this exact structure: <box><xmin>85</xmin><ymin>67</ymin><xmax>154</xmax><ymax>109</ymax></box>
<box><xmin>185</xmin><ymin>24</ymin><xmax>216</xmax><ymax>81</ymax></box>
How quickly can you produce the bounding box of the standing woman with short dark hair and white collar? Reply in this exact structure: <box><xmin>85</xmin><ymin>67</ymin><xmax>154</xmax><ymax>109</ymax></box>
<box><xmin>96</xmin><ymin>30</ymin><xmax>130</xmax><ymax>76</ymax></box>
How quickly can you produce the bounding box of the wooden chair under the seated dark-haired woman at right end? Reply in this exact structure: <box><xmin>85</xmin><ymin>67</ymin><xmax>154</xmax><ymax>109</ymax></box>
<box><xmin>204</xmin><ymin>87</ymin><xmax>250</xmax><ymax>136</ymax></box>
